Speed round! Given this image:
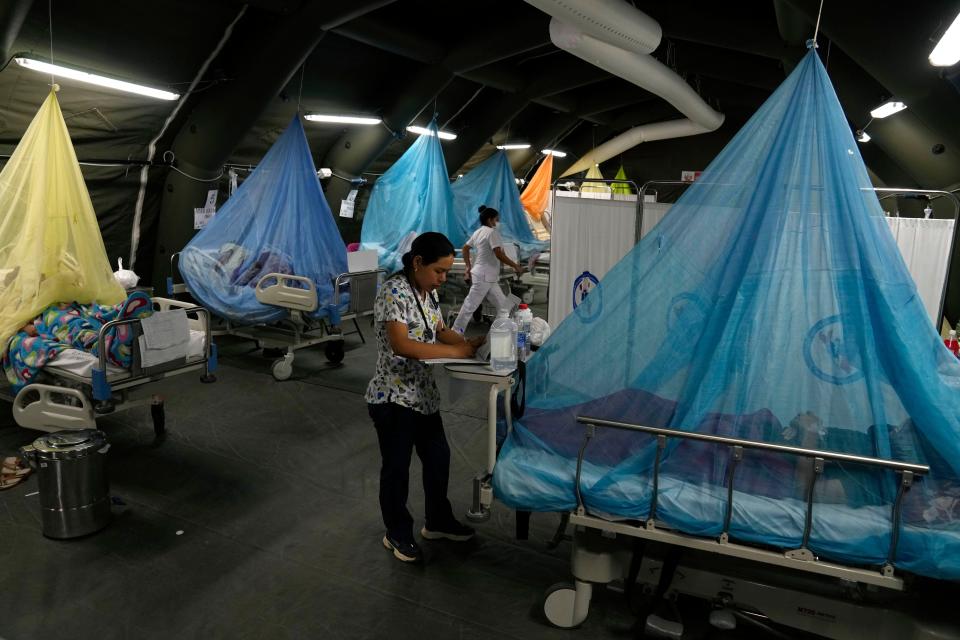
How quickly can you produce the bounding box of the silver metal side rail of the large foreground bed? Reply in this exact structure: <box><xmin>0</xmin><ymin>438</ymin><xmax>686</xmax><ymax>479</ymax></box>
<box><xmin>574</xmin><ymin>416</ymin><xmax>930</xmax><ymax>577</ymax></box>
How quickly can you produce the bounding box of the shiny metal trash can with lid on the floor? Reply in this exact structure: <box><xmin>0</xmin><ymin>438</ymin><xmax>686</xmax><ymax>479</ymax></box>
<box><xmin>21</xmin><ymin>429</ymin><xmax>110</xmax><ymax>538</ymax></box>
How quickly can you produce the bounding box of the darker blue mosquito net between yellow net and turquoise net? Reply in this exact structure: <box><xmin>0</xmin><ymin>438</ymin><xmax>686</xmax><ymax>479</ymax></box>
<box><xmin>180</xmin><ymin>115</ymin><xmax>347</xmax><ymax>324</ymax></box>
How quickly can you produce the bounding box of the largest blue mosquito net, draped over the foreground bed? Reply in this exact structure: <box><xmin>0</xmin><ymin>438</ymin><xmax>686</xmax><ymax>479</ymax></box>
<box><xmin>494</xmin><ymin>51</ymin><xmax>960</xmax><ymax>579</ymax></box>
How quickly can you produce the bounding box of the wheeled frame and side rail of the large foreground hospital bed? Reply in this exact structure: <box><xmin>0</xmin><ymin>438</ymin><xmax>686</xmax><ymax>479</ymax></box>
<box><xmin>532</xmin><ymin>417</ymin><xmax>960</xmax><ymax>640</ymax></box>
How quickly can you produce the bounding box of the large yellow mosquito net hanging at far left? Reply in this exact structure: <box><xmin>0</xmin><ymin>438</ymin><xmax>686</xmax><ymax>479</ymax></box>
<box><xmin>0</xmin><ymin>91</ymin><xmax>124</xmax><ymax>347</ymax></box>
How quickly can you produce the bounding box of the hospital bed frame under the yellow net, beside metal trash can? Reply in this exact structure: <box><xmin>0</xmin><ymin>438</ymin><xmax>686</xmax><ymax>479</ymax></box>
<box><xmin>0</xmin><ymin>298</ymin><xmax>217</xmax><ymax>436</ymax></box>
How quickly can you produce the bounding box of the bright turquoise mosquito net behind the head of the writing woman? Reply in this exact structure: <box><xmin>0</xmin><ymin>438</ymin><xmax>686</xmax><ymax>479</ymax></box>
<box><xmin>360</xmin><ymin>121</ymin><xmax>466</xmax><ymax>271</ymax></box>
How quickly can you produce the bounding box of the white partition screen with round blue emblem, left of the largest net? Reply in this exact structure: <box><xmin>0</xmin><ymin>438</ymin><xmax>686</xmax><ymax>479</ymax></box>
<box><xmin>547</xmin><ymin>191</ymin><xmax>637</xmax><ymax>327</ymax></box>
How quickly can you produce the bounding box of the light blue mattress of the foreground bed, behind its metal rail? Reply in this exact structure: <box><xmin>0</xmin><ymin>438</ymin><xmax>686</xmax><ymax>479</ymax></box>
<box><xmin>494</xmin><ymin>426</ymin><xmax>960</xmax><ymax>580</ymax></box>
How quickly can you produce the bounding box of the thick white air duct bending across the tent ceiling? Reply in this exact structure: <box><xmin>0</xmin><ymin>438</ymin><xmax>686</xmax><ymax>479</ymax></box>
<box><xmin>527</xmin><ymin>0</ymin><xmax>723</xmax><ymax>176</ymax></box>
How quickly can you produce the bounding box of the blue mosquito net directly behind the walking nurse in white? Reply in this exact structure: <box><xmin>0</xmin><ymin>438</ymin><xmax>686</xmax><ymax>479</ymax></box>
<box><xmin>451</xmin><ymin>150</ymin><xmax>550</xmax><ymax>260</ymax></box>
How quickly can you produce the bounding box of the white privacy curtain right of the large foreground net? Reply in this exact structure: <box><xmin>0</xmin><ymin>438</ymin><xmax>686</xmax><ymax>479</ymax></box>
<box><xmin>887</xmin><ymin>217</ymin><xmax>953</xmax><ymax>330</ymax></box>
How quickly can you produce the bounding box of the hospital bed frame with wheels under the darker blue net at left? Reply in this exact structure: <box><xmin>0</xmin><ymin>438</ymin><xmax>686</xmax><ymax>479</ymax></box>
<box><xmin>167</xmin><ymin>252</ymin><xmax>384</xmax><ymax>381</ymax></box>
